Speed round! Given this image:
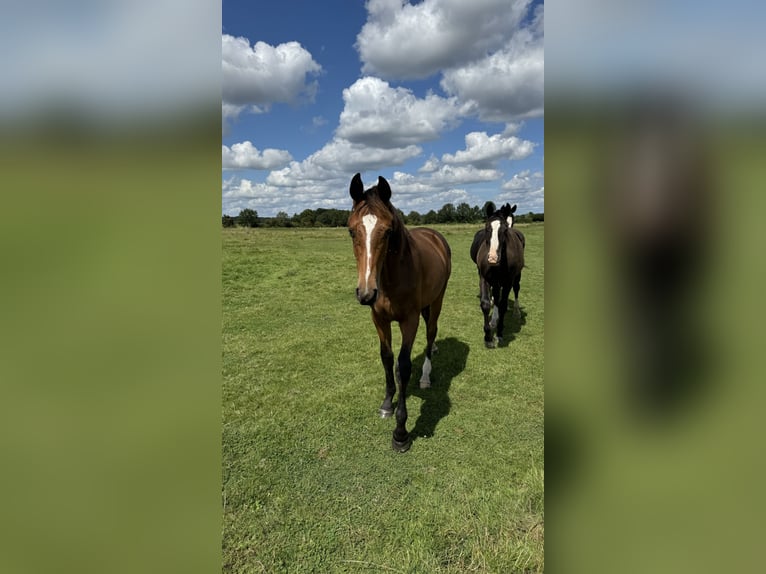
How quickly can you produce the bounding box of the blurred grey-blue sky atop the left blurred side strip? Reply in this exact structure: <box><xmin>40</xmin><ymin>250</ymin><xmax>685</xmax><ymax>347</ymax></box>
<box><xmin>0</xmin><ymin>0</ymin><xmax>221</xmax><ymax>126</ymax></box>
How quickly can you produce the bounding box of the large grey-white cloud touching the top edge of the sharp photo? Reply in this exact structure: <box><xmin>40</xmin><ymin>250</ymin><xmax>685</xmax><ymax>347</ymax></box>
<box><xmin>356</xmin><ymin>0</ymin><xmax>530</xmax><ymax>79</ymax></box>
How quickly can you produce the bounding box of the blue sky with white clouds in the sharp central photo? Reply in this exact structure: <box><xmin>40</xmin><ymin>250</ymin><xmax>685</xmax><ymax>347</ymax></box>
<box><xmin>222</xmin><ymin>0</ymin><xmax>544</xmax><ymax>216</ymax></box>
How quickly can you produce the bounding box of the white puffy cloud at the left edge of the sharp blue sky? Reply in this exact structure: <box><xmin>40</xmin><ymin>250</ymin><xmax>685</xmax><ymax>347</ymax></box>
<box><xmin>221</xmin><ymin>34</ymin><xmax>322</xmax><ymax>107</ymax></box>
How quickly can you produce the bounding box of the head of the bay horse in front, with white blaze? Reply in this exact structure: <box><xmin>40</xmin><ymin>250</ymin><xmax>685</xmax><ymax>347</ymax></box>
<box><xmin>348</xmin><ymin>173</ymin><xmax>400</xmax><ymax>305</ymax></box>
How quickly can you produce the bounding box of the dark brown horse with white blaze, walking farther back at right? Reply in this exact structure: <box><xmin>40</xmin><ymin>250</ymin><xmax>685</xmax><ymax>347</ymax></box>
<box><xmin>471</xmin><ymin>203</ymin><xmax>526</xmax><ymax>349</ymax></box>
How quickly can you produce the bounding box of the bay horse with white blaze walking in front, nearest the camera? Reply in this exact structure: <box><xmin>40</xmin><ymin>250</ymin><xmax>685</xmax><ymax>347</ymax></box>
<box><xmin>348</xmin><ymin>173</ymin><xmax>452</xmax><ymax>452</ymax></box>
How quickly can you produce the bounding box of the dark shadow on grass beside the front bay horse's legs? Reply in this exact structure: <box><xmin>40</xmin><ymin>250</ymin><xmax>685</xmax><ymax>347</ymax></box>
<box><xmin>407</xmin><ymin>337</ymin><xmax>470</xmax><ymax>441</ymax></box>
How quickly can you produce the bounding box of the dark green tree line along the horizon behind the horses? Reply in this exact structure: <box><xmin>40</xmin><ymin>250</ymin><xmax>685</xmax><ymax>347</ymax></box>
<box><xmin>222</xmin><ymin>201</ymin><xmax>545</xmax><ymax>227</ymax></box>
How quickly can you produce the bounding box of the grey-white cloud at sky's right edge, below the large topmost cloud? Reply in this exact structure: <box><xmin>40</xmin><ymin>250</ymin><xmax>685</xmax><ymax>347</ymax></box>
<box><xmin>441</xmin><ymin>6</ymin><xmax>545</xmax><ymax>121</ymax></box>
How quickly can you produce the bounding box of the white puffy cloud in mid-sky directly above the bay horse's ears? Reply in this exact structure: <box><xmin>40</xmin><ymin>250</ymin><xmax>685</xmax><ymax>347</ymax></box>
<box><xmin>336</xmin><ymin>77</ymin><xmax>461</xmax><ymax>148</ymax></box>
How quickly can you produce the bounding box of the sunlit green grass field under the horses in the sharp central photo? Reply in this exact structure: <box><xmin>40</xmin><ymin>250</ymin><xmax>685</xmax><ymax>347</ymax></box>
<box><xmin>222</xmin><ymin>224</ymin><xmax>544</xmax><ymax>573</ymax></box>
